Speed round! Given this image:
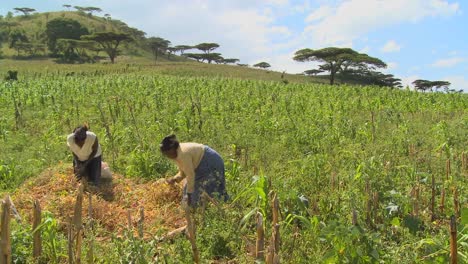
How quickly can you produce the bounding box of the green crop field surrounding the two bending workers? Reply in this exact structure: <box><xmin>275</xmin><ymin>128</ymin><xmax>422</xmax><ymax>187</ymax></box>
<box><xmin>0</xmin><ymin>64</ymin><xmax>468</xmax><ymax>263</ymax></box>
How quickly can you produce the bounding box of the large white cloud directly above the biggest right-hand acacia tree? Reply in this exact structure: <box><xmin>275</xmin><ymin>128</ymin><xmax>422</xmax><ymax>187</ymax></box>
<box><xmin>304</xmin><ymin>0</ymin><xmax>460</xmax><ymax>46</ymax></box>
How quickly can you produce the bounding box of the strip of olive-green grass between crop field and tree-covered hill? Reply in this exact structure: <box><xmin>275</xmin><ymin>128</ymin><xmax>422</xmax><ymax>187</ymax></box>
<box><xmin>0</xmin><ymin>56</ymin><xmax>328</xmax><ymax>84</ymax></box>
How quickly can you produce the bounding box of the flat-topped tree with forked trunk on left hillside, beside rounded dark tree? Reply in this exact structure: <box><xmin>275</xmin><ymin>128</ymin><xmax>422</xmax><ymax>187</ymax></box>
<box><xmin>81</xmin><ymin>32</ymin><xmax>132</xmax><ymax>63</ymax></box>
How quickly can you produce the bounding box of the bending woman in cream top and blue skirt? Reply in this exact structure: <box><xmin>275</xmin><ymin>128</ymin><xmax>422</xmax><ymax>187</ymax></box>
<box><xmin>159</xmin><ymin>135</ymin><xmax>229</xmax><ymax>208</ymax></box>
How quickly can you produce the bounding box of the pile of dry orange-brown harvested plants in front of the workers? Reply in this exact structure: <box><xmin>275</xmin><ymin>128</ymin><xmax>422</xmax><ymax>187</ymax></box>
<box><xmin>11</xmin><ymin>164</ymin><xmax>185</xmax><ymax>234</ymax></box>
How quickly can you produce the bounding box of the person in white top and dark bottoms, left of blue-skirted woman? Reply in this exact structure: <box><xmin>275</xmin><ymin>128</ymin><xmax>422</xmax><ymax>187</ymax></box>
<box><xmin>67</xmin><ymin>125</ymin><xmax>102</xmax><ymax>186</ymax></box>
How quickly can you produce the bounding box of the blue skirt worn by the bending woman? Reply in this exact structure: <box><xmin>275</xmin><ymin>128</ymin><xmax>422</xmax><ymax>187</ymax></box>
<box><xmin>184</xmin><ymin>146</ymin><xmax>229</xmax><ymax>207</ymax></box>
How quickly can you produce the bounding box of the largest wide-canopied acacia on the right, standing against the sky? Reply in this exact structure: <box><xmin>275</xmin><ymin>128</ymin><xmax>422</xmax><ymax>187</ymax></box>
<box><xmin>293</xmin><ymin>47</ymin><xmax>387</xmax><ymax>85</ymax></box>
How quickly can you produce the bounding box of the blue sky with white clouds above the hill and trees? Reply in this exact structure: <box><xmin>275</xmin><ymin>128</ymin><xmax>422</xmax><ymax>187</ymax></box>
<box><xmin>0</xmin><ymin>0</ymin><xmax>468</xmax><ymax>92</ymax></box>
